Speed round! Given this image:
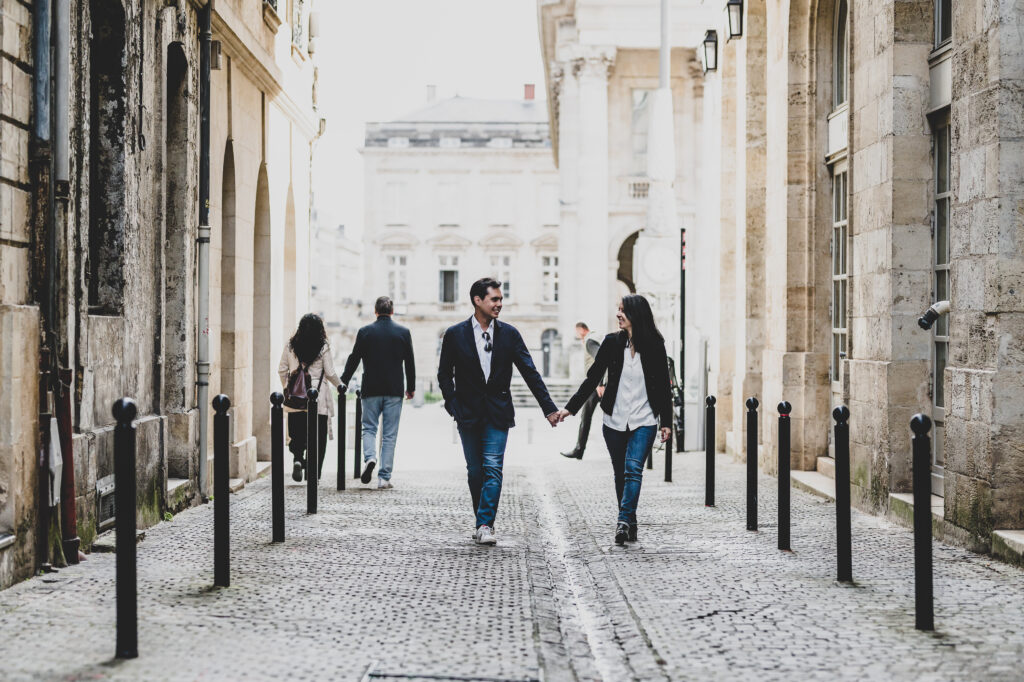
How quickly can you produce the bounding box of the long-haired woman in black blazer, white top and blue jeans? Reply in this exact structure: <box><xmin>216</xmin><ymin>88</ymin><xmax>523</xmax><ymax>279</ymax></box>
<box><xmin>559</xmin><ymin>295</ymin><xmax>673</xmax><ymax>545</ymax></box>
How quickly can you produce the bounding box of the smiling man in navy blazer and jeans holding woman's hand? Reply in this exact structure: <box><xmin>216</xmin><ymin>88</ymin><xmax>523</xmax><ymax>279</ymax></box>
<box><xmin>437</xmin><ymin>278</ymin><xmax>558</xmax><ymax>545</ymax></box>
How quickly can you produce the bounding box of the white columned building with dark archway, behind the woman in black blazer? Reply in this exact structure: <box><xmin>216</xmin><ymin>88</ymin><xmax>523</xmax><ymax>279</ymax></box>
<box><xmin>539</xmin><ymin>0</ymin><xmax>722</xmax><ymax>447</ymax></box>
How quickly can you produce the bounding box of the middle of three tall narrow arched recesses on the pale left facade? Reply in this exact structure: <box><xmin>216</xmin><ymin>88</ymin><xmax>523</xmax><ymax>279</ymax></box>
<box><xmin>252</xmin><ymin>164</ymin><xmax>274</xmax><ymax>461</ymax></box>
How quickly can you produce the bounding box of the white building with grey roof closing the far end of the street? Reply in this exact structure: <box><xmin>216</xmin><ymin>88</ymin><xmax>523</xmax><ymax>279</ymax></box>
<box><xmin>362</xmin><ymin>85</ymin><xmax>574</xmax><ymax>389</ymax></box>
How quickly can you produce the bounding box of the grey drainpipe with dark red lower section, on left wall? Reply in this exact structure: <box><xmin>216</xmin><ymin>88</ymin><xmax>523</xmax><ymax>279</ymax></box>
<box><xmin>50</xmin><ymin>0</ymin><xmax>81</xmax><ymax>563</ymax></box>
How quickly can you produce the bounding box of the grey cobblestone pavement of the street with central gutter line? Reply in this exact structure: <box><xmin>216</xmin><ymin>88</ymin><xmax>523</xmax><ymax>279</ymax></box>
<box><xmin>0</xmin><ymin>406</ymin><xmax>1024</xmax><ymax>681</ymax></box>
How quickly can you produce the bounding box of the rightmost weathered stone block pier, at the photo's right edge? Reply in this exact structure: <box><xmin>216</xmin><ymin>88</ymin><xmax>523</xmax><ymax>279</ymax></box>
<box><xmin>945</xmin><ymin>0</ymin><xmax>1024</xmax><ymax>542</ymax></box>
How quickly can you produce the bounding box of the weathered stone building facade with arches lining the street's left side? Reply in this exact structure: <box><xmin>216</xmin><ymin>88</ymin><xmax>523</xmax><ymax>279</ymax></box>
<box><xmin>0</xmin><ymin>0</ymin><xmax>319</xmax><ymax>587</ymax></box>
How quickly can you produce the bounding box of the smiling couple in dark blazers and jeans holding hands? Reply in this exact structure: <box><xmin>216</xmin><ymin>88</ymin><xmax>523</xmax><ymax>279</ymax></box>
<box><xmin>437</xmin><ymin>278</ymin><xmax>673</xmax><ymax>545</ymax></box>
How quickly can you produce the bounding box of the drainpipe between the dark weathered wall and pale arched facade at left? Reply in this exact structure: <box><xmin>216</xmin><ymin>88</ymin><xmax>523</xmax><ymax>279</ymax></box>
<box><xmin>196</xmin><ymin>0</ymin><xmax>213</xmax><ymax>498</ymax></box>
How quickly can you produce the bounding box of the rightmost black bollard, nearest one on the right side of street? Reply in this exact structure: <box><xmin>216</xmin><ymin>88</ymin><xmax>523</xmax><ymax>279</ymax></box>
<box><xmin>910</xmin><ymin>415</ymin><xmax>935</xmax><ymax>630</ymax></box>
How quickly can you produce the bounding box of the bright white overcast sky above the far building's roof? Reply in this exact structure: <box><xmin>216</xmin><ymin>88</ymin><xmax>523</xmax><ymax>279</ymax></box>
<box><xmin>313</xmin><ymin>0</ymin><xmax>544</xmax><ymax>239</ymax></box>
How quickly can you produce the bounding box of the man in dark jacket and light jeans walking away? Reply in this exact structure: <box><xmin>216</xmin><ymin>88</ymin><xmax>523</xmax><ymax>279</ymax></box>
<box><xmin>341</xmin><ymin>296</ymin><xmax>416</xmax><ymax>488</ymax></box>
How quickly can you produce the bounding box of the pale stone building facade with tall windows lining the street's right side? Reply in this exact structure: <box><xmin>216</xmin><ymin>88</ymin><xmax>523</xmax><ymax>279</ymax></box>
<box><xmin>706</xmin><ymin>0</ymin><xmax>1024</xmax><ymax>550</ymax></box>
